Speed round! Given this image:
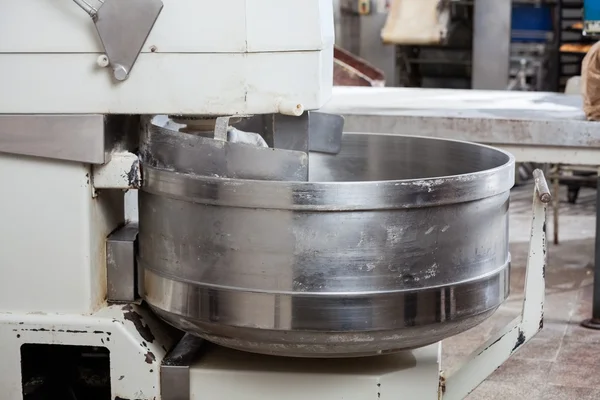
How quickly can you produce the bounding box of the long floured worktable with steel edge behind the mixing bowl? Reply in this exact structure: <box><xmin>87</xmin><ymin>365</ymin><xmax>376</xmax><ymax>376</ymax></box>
<box><xmin>323</xmin><ymin>88</ymin><xmax>600</xmax><ymax>165</ymax></box>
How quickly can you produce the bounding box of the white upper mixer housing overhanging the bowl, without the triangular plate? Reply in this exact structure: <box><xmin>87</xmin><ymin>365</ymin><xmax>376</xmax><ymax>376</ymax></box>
<box><xmin>0</xmin><ymin>0</ymin><xmax>334</xmax><ymax>115</ymax></box>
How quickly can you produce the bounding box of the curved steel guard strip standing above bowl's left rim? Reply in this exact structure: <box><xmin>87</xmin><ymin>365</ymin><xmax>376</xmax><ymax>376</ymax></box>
<box><xmin>140</xmin><ymin>117</ymin><xmax>308</xmax><ymax>181</ymax></box>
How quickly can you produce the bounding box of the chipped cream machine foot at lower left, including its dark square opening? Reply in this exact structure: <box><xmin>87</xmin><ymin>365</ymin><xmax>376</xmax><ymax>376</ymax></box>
<box><xmin>0</xmin><ymin>304</ymin><xmax>173</xmax><ymax>400</ymax></box>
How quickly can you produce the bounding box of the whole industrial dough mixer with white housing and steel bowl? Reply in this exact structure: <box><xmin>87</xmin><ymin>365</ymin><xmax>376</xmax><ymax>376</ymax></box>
<box><xmin>0</xmin><ymin>0</ymin><xmax>549</xmax><ymax>400</ymax></box>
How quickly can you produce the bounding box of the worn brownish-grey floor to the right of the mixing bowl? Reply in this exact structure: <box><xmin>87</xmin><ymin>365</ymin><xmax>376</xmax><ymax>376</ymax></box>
<box><xmin>442</xmin><ymin>186</ymin><xmax>600</xmax><ymax>400</ymax></box>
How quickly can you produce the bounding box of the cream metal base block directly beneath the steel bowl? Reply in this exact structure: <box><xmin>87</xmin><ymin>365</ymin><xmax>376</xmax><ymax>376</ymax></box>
<box><xmin>183</xmin><ymin>342</ymin><xmax>441</xmax><ymax>400</ymax></box>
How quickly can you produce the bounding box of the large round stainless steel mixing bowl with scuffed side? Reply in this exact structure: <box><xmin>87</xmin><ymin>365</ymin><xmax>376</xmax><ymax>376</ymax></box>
<box><xmin>138</xmin><ymin>123</ymin><xmax>514</xmax><ymax>357</ymax></box>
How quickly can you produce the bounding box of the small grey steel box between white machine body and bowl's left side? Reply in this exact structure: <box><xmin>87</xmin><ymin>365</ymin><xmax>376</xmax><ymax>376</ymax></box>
<box><xmin>106</xmin><ymin>223</ymin><xmax>138</xmax><ymax>302</ymax></box>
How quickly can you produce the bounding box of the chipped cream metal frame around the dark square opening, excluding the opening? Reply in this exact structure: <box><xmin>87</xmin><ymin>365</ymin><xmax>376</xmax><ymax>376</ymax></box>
<box><xmin>0</xmin><ymin>304</ymin><xmax>173</xmax><ymax>400</ymax></box>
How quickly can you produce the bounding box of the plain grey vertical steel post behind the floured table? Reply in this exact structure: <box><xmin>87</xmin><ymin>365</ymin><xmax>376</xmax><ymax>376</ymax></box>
<box><xmin>471</xmin><ymin>0</ymin><xmax>512</xmax><ymax>90</ymax></box>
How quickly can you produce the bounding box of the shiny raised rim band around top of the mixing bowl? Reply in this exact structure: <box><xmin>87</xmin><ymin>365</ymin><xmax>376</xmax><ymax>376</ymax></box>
<box><xmin>142</xmin><ymin>133</ymin><xmax>515</xmax><ymax>211</ymax></box>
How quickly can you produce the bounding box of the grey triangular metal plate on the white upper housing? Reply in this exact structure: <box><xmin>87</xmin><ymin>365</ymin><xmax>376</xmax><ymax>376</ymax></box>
<box><xmin>73</xmin><ymin>0</ymin><xmax>163</xmax><ymax>81</ymax></box>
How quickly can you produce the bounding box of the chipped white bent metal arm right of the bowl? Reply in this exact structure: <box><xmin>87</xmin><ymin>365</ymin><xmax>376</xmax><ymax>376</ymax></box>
<box><xmin>440</xmin><ymin>169</ymin><xmax>551</xmax><ymax>400</ymax></box>
